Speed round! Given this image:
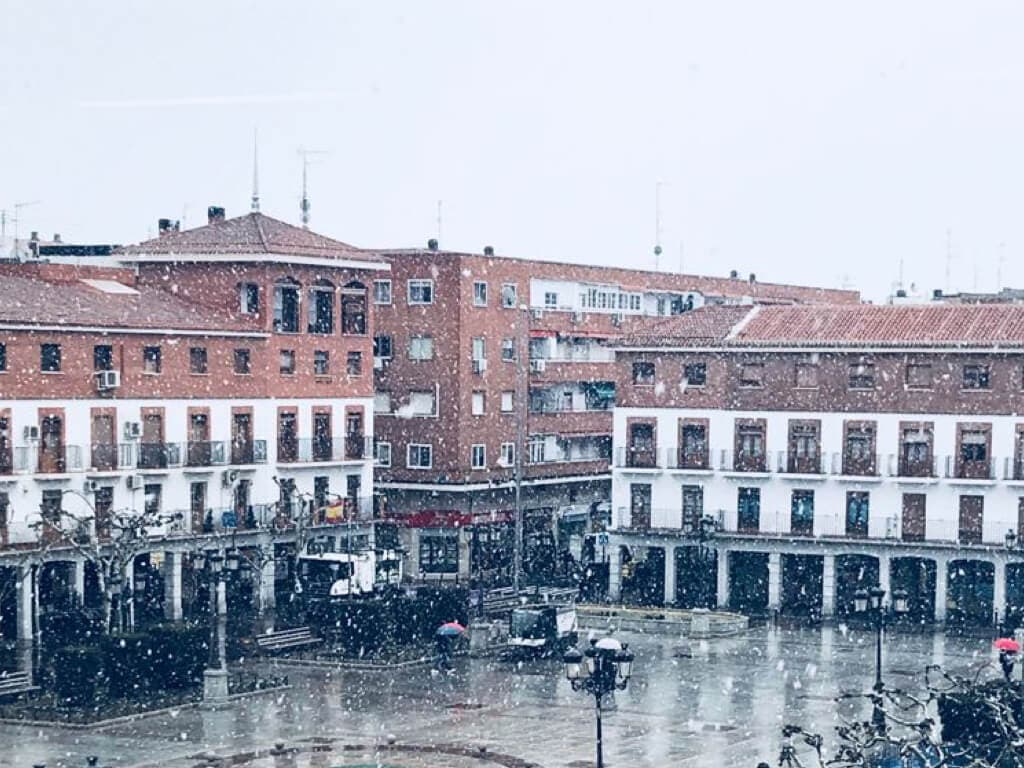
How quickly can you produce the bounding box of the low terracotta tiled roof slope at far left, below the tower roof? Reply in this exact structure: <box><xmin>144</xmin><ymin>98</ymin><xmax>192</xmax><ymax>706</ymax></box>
<box><xmin>0</xmin><ymin>273</ymin><xmax>261</xmax><ymax>333</ymax></box>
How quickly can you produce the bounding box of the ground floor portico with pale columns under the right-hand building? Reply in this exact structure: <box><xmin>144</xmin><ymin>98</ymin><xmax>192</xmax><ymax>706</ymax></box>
<box><xmin>608</xmin><ymin>530</ymin><xmax>1024</xmax><ymax>627</ymax></box>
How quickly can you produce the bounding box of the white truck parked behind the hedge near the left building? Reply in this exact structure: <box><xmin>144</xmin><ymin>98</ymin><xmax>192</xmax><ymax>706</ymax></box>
<box><xmin>298</xmin><ymin>547</ymin><xmax>402</xmax><ymax>601</ymax></box>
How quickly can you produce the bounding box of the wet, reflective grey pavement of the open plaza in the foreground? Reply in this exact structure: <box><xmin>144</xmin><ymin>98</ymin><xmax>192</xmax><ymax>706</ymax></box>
<box><xmin>0</xmin><ymin>627</ymin><xmax>995</xmax><ymax>768</ymax></box>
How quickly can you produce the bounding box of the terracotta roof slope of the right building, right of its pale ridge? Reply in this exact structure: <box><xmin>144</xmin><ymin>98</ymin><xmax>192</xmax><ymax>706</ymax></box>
<box><xmin>729</xmin><ymin>304</ymin><xmax>1024</xmax><ymax>346</ymax></box>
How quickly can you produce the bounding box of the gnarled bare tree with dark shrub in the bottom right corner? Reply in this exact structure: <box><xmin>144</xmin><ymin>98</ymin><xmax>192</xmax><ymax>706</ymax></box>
<box><xmin>778</xmin><ymin>665</ymin><xmax>1024</xmax><ymax>768</ymax></box>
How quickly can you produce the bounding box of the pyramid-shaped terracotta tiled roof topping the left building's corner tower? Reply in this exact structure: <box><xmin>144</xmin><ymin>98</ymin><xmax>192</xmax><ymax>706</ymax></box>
<box><xmin>117</xmin><ymin>213</ymin><xmax>375</xmax><ymax>261</ymax></box>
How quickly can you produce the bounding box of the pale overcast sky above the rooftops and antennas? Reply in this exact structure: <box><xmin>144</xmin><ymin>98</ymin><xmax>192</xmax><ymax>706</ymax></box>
<box><xmin>0</xmin><ymin>0</ymin><xmax>1024</xmax><ymax>298</ymax></box>
